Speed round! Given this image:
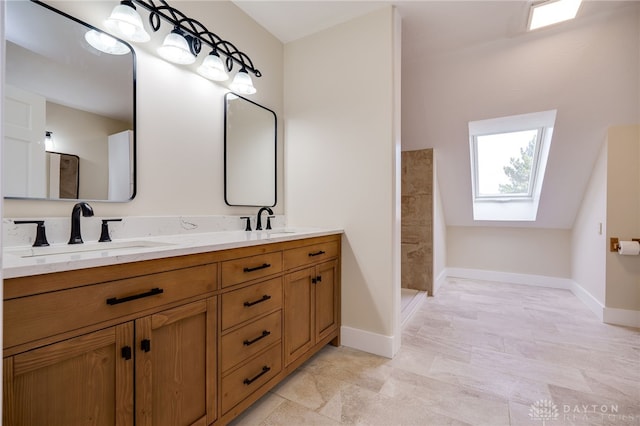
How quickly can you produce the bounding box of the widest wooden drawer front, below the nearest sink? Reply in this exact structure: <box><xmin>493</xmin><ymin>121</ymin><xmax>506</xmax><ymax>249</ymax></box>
<box><xmin>4</xmin><ymin>264</ymin><xmax>217</xmax><ymax>348</ymax></box>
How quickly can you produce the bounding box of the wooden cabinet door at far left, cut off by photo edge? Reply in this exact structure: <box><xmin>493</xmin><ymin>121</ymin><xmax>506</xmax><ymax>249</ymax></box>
<box><xmin>3</xmin><ymin>322</ymin><xmax>134</xmax><ymax>426</ymax></box>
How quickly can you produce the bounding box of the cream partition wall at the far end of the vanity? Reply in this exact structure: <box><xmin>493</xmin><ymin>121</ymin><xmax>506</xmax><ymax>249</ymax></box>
<box><xmin>285</xmin><ymin>7</ymin><xmax>400</xmax><ymax>356</ymax></box>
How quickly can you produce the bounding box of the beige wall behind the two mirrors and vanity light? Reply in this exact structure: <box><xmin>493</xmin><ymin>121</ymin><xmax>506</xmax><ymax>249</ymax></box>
<box><xmin>4</xmin><ymin>1</ymin><xmax>284</xmax><ymax>217</ymax></box>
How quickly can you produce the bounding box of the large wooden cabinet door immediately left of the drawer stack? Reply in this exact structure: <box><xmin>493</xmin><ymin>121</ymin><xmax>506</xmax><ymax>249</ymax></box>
<box><xmin>136</xmin><ymin>298</ymin><xmax>216</xmax><ymax>426</ymax></box>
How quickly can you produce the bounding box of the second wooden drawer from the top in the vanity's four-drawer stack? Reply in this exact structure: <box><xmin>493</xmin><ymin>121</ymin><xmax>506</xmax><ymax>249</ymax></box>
<box><xmin>222</xmin><ymin>277</ymin><xmax>282</xmax><ymax>330</ymax></box>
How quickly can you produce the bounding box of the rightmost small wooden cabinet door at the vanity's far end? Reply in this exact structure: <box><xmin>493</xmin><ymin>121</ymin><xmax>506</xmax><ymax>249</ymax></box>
<box><xmin>314</xmin><ymin>261</ymin><xmax>339</xmax><ymax>341</ymax></box>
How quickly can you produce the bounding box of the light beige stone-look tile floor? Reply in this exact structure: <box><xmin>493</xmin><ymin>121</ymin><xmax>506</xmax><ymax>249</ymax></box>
<box><xmin>233</xmin><ymin>279</ymin><xmax>640</xmax><ymax>426</ymax></box>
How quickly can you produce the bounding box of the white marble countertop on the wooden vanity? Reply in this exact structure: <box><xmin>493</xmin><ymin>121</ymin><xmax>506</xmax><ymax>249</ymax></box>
<box><xmin>2</xmin><ymin>228</ymin><xmax>343</xmax><ymax>279</ymax></box>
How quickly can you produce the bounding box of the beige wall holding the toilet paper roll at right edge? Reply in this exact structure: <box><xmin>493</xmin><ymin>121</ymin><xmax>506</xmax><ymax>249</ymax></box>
<box><xmin>605</xmin><ymin>125</ymin><xmax>640</xmax><ymax>311</ymax></box>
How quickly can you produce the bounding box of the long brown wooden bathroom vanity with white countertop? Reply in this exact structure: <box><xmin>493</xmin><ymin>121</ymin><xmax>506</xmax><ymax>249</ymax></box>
<box><xmin>3</xmin><ymin>231</ymin><xmax>341</xmax><ymax>426</ymax></box>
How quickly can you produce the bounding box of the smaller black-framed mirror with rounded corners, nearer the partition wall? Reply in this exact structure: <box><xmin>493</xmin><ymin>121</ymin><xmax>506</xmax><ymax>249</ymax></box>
<box><xmin>224</xmin><ymin>93</ymin><xmax>276</xmax><ymax>207</ymax></box>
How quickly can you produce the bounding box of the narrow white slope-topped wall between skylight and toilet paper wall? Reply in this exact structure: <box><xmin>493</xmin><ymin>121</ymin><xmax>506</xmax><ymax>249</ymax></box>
<box><xmin>571</xmin><ymin>142</ymin><xmax>608</xmax><ymax>307</ymax></box>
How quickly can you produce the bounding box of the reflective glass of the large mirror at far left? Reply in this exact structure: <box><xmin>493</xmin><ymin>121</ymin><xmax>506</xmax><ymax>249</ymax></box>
<box><xmin>2</xmin><ymin>1</ymin><xmax>135</xmax><ymax>202</ymax></box>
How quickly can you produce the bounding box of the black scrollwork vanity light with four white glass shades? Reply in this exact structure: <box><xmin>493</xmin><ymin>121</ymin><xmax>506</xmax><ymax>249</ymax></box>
<box><xmin>105</xmin><ymin>0</ymin><xmax>262</xmax><ymax>95</ymax></box>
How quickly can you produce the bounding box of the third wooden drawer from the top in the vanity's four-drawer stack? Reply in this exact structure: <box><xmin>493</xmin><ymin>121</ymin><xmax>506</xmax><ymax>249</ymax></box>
<box><xmin>220</xmin><ymin>311</ymin><xmax>282</xmax><ymax>372</ymax></box>
